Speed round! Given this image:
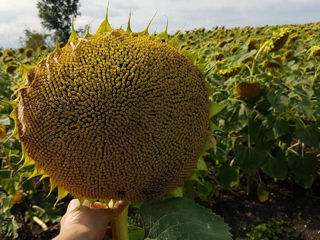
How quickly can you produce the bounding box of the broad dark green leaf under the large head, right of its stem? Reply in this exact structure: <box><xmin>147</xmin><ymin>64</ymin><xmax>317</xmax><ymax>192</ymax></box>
<box><xmin>140</xmin><ymin>198</ymin><xmax>231</xmax><ymax>240</ymax></box>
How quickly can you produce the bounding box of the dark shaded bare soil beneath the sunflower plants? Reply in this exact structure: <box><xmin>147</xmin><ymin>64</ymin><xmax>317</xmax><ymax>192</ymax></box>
<box><xmin>19</xmin><ymin>177</ymin><xmax>320</xmax><ymax>240</ymax></box>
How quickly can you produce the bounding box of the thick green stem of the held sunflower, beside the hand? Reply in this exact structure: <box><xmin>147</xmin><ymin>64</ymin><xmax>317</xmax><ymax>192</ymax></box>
<box><xmin>111</xmin><ymin>206</ymin><xmax>129</xmax><ymax>240</ymax></box>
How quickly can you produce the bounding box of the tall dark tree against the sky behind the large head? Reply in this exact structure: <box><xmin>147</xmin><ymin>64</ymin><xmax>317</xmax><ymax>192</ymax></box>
<box><xmin>37</xmin><ymin>0</ymin><xmax>80</xmax><ymax>42</ymax></box>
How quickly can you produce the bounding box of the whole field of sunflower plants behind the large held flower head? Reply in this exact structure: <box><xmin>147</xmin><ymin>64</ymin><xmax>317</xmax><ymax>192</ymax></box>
<box><xmin>0</xmin><ymin>23</ymin><xmax>320</xmax><ymax>240</ymax></box>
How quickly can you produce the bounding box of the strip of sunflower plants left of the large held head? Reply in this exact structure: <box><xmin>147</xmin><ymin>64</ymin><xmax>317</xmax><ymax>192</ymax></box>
<box><xmin>0</xmin><ymin>50</ymin><xmax>61</xmax><ymax>239</ymax></box>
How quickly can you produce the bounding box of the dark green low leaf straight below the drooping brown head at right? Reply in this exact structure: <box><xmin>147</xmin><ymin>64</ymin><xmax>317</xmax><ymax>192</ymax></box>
<box><xmin>235</xmin><ymin>145</ymin><xmax>267</xmax><ymax>174</ymax></box>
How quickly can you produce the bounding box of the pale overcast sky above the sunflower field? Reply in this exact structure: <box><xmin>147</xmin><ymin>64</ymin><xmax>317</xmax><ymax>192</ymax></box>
<box><xmin>0</xmin><ymin>0</ymin><xmax>320</xmax><ymax>48</ymax></box>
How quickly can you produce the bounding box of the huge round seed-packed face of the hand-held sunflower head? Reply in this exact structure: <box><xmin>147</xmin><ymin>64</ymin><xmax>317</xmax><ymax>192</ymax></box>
<box><xmin>17</xmin><ymin>30</ymin><xmax>209</xmax><ymax>201</ymax></box>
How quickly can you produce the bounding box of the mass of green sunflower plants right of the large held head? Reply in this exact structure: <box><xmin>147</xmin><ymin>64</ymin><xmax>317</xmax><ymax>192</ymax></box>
<box><xmin>174</xmin><ymin>24</ymin><xmax>320</xmax><ymax>191</ymax></box>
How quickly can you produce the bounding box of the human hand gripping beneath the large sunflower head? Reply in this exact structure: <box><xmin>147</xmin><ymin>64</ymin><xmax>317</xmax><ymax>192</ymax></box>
<box><xmin>53</xmin><ymin>199</ymin><xmax>128</xmax><ymax>240</ymax></box>
